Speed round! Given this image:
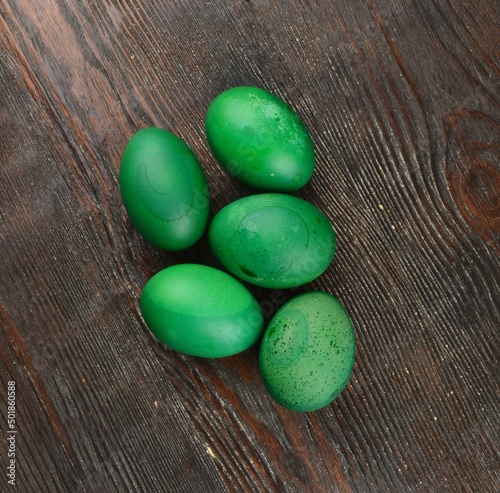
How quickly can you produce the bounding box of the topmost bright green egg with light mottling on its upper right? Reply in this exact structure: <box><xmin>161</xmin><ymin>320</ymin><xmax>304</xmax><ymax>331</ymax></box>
<box><xmin>205</xmin><ymin>86</ymin><xmax>315</xmax><ymax>192</ymax></box>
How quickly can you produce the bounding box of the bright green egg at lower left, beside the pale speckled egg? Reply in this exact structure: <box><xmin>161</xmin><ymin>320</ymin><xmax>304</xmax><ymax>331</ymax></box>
<box><xmin>140</xmin><ymin>264</ymin><xmax>263</xmax><ymax>358</ymax></box>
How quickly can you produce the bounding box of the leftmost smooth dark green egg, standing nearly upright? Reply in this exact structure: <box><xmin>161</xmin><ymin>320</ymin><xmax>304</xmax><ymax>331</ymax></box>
<box><xmin>120</xmin><ymin>127</ymin><xmax>210</xmax><ymax>251</ymax></box>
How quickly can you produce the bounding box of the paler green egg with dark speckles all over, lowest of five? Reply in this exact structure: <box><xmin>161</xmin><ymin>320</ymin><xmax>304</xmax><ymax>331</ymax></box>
<box><xmin>259</xmin><ymin>291</ymin><xmax>356</xmax><ymax>411</ymax></box>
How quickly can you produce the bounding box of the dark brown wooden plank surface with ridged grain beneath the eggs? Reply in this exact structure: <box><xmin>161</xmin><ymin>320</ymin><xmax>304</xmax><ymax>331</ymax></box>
<box><xmin>0</xmin><ymin>0</ymin><xmax>500</xmax><ymax>493</ymax></box>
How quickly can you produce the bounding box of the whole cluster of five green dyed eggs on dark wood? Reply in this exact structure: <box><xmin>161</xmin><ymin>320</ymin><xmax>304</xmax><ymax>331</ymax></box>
<box><xmin>119</xmin><ymin>86</ymin><xmax>356</xmax><ymax>411</ymax></box>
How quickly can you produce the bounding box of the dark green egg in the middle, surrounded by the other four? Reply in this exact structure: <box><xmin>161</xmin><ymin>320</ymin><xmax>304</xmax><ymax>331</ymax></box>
<box><xmin>208</xmin><ymin>193</ymin><xmax>336</xmax><ymax>288</ymax></box>
